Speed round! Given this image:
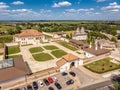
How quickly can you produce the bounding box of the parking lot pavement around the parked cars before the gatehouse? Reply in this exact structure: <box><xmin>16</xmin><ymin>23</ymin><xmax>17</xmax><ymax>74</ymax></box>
<box><xmin>13</xmin><ymin>72</ymin><xmax>79</xmax><ymax>90</ymax></box>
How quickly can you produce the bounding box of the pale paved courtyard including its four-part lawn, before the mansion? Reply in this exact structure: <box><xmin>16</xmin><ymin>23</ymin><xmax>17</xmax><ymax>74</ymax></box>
<box><xmin>20</xmin><ymin>42</ymin><xmax>74</xmax><ymax>72</ymax></box>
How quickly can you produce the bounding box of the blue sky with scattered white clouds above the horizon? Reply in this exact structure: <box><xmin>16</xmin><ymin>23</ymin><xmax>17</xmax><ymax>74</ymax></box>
<box><xmin>0</xmin><ymin>0</ymin><xmax>120</xmax><ymax>20</ymax></box>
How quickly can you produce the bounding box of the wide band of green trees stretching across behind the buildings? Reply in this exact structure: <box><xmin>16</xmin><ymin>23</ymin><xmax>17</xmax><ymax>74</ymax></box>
<box><xmin>0</xmin><ymin>21</ymin><xmax>120</xmax><ymax>35</ymax></box>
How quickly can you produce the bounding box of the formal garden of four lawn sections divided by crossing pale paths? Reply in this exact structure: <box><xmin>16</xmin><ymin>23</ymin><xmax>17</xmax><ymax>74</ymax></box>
<box><xmin>29</xmin><ymin>45</ymin><xmax>67</xmax><ymax>61</ymax></box>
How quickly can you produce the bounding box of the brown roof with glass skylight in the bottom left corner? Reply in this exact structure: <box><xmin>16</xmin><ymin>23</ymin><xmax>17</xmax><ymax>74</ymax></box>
<box><xmin>0</xmin><ymin>57</ymin><xmax>29</xmax><ymax>82</ymax></box>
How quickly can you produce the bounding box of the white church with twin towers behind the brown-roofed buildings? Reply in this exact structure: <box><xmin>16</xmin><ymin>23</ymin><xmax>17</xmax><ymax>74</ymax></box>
<box><xmin>72</xmin><ymin>27</ymin><xmax>87</xmax><ymax>40</ymax></box>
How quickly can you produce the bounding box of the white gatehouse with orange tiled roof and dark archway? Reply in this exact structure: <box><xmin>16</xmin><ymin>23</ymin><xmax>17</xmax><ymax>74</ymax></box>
<box><xmin>56</xmin><ymin>53</ymin><xmax>83</xmax><ymax>72</ymax></box>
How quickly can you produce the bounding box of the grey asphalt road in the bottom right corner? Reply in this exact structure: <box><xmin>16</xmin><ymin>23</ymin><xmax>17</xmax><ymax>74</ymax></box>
<box><xmin>76</xmin><ymin>80</ymin><xmax>114</xmax><ymax>90</ymax></box>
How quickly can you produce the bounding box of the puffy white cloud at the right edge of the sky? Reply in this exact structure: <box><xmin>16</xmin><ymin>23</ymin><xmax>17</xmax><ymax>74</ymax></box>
<box><xmin>101</xmin><ymin>2</ymin><xmax>120</xmax><ymax>12</ymax></box>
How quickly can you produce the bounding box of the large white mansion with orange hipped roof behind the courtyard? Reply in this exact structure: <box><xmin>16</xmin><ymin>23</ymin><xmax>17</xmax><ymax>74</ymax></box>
<box><xmin>13</xmin><ymin>29</ymin><xmax>45</xmax><ymax>45</ymax></box>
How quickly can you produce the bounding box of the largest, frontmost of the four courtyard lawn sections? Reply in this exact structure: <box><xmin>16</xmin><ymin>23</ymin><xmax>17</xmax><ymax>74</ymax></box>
<box><xmin>33</xmin><ymin>53</ymin><xmax>53</xmax><ymax>61</ymax></box>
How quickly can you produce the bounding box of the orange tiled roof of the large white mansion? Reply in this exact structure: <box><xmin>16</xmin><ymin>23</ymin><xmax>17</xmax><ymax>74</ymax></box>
<box><xmin>15</xmin><ymin>29</ymin><xmax>43</xmax><ymax>37</ymax></box>
